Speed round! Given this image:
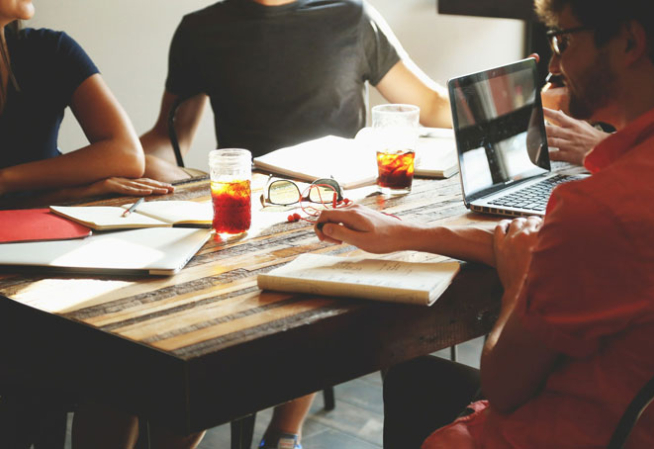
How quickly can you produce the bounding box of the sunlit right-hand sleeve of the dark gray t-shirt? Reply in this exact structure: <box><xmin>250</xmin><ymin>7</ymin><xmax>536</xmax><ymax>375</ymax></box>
<box><xmin>362</xmin><ymin>1</ymin><xmax>404</xmax><ymax>86</ymax></box>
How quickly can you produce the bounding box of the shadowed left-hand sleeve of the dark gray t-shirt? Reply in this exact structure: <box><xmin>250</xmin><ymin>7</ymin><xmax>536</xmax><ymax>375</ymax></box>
<box><xmin>166</xmin><ymin>19</ymin><xmax>200</xmax><ymax>97</ymax></box>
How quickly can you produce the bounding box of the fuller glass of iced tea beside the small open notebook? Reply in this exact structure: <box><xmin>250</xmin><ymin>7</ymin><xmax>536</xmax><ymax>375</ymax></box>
<box><xmin>209</xmin><ymin>148</ymin><xmax>252</xmax><ymax>236</ymax></box>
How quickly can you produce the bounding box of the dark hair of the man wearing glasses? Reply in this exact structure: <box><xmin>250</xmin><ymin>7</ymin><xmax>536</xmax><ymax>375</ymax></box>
<box><xmin>535</xmin><ymin>0</ymin><xmax>654</xmax><ymax>62</ymax></box>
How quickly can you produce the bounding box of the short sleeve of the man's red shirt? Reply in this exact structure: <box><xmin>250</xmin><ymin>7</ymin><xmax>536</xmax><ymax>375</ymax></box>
<box><xmin>516</xmin><ymin>185</ymin><xmax>652</xmax><ymax>357</ymax></box>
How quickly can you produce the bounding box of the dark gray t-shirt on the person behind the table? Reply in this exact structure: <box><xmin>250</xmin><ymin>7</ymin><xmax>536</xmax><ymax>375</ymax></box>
<box><xmin>166</xmin><ymin>0</ymin><xmax>399</xmax><ymax>156</ymax></box>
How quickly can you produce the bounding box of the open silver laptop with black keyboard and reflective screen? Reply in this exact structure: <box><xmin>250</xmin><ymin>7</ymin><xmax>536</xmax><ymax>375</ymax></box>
<box><xmin>448</xmin><ymin>58</ymin><xmax>585</xmax><ymax>216</ymax></box>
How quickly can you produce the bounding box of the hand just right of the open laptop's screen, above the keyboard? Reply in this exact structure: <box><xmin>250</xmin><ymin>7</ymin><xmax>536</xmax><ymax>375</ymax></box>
<box><xmin>543</xmin><ymin>108</ymin><xmax>609</xmax><ymax>165</ymax></box>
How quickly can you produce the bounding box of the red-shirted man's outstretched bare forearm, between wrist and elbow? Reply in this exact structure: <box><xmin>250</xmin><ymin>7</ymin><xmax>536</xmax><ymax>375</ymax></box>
<box><xmin>405</xmin><ymin>221</ymin><xmax>495</xmax><ymax>266</ymax></box>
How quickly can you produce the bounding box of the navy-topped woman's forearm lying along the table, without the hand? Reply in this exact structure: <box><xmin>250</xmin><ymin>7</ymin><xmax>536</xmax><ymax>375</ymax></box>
<box><xmin>0</xmin><ymin>139</ymin><xmax>145</xmax><ymax>193</ymax></box>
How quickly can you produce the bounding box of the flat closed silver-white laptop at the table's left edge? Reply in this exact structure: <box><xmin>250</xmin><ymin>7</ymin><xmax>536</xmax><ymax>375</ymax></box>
<box><xmin>0</xmin><ymin>228</ymin><xmax>211</xmax><ymax>276</ymax></box>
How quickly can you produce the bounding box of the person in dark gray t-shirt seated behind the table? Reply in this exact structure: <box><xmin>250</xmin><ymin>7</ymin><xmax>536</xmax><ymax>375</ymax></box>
<box><xmin>141</xmin><ymin>0</ymin><xmax>451</xmax><ymax>449</ymax></box>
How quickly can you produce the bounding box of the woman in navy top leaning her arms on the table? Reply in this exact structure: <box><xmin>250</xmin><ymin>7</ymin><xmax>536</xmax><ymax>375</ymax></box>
<box><xmin>0</xmin><ymin>0</ymin><xmax>211</xmax><ymax>449</ymax></box>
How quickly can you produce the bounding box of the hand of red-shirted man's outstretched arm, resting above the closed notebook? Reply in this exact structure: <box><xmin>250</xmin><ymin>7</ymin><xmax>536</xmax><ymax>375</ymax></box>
<box><xmin>315</xmin><ymin>205</ymin><xmax>407</xmax><ymax>254</ymax></box>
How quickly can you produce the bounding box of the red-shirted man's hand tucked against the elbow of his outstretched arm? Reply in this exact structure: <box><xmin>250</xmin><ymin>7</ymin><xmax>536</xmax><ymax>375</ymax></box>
<box><xmin>493</xmin><ymin>217</ymin><xmax>543</xmax><ymax>299</ymax></box>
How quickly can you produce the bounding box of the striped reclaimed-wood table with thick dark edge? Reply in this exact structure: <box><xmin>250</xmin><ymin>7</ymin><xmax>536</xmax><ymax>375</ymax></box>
<box><xmin>0</xmin><ymin>177</ymin><xmax>501</xmax><ymax>433</ymax></box>
